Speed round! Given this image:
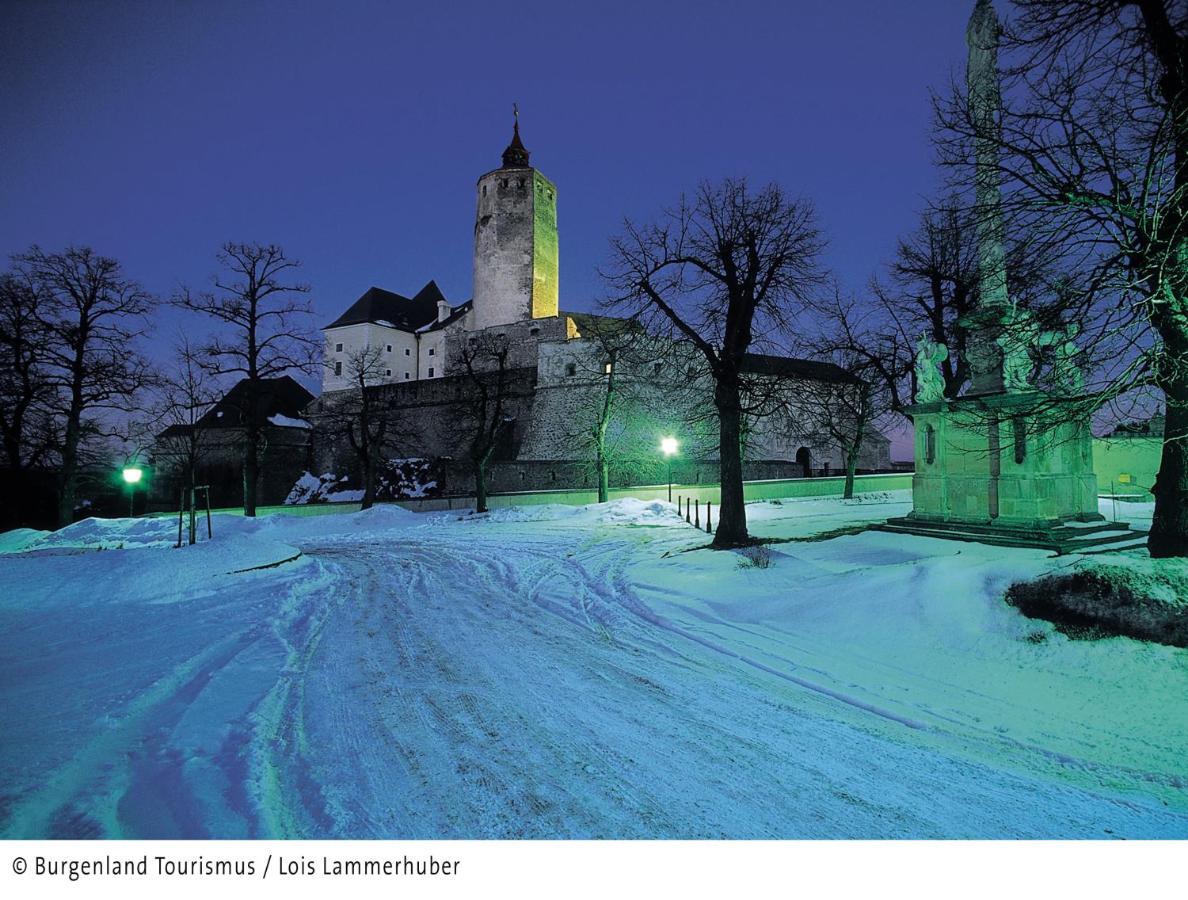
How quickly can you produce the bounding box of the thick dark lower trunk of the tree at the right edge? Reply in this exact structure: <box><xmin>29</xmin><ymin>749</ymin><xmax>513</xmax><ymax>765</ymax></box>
<box><xmin>1146</xmin><ymin>358</ymin><xmax>1188</xmax><ymax>558</ymax></box>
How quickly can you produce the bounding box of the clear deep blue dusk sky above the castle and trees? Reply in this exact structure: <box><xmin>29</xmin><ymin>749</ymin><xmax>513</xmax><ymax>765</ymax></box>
<box><xmin>0</xmin><ymin>0</ymin><xmax>972</xmax><ymax>351</ymax></box>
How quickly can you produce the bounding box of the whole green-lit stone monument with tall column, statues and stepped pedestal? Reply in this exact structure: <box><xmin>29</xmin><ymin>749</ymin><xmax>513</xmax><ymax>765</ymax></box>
<box><xmin>885</xmin><ymin>0</ymin><xmax>1133</xmax><ymax>552</ymax></box>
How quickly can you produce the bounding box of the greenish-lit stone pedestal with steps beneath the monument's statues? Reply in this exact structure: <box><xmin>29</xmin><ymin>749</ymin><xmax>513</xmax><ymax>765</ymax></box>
<box><xmin>884</xmin><ymin>391</ymin><xmax>1139</xmax><ymax>552</ymax></box>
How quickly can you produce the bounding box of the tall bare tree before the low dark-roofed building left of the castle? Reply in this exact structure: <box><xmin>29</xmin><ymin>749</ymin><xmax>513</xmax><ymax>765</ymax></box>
<box><xmin>176</xmin><ymin>242</ymin><xmax>320</xmax><ymax>515</ymax></box>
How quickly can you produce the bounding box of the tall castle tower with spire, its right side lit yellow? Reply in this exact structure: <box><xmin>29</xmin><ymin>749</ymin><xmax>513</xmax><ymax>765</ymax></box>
<box><xmin>473</xmin><ymin>116</ymin><xmax>558</xmax><ymax>329</ymax></box>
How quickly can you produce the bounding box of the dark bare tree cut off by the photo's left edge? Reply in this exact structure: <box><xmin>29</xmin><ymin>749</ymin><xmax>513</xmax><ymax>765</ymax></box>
<box><xmin>0</xmin><ymin>272</ymin><xmax>56</xmax><ymax>477</ymax></box>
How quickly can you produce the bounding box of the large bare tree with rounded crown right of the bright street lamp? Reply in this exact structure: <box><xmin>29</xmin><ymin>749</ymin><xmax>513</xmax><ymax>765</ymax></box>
<box><xmin>606</xmin><ymin>179</ymin><xmax>823</xmax><ymax>546</ymax></box>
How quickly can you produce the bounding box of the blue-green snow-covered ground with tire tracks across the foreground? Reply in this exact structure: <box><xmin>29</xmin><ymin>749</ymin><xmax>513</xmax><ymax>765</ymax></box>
<box><xmin>0</xmin><ymin>493</ymin><xmax>1188</xmax><ymax>837</ymax></box>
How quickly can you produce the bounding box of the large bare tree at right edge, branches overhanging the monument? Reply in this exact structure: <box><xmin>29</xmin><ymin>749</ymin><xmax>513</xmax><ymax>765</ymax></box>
<box><xmin>939</xmin><ymin>0</ymin><xmax>1188</xmax><ymax>557</ymax></box>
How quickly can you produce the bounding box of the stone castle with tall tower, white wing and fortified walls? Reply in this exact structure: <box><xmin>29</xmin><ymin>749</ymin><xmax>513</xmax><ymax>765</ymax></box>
<box><xmin>307</xmin><ymin>120</ymin><xmax>890</xmax><ymax>501</ymax></box>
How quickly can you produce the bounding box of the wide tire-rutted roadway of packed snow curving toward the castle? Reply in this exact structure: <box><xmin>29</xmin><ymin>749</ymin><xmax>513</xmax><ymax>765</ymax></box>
<box><xmin>282</xmin><ymin>527</ymin><xmax>1183</xmax><ymax>837</ymax></box>
